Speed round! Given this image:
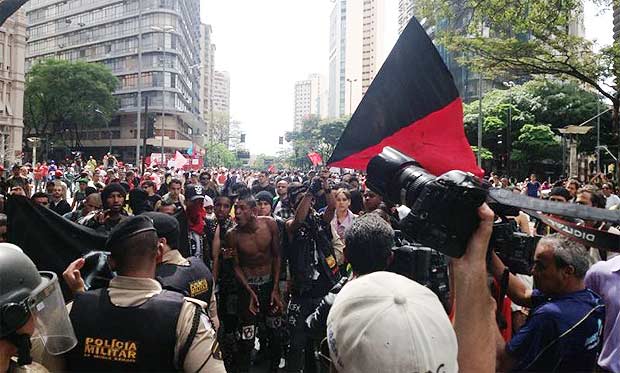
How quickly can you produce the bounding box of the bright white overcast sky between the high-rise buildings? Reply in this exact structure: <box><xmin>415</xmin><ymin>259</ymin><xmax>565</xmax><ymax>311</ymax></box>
<box><xmin>201</xmin><ymin>0</ymin><xmax>612</xmax><ymax>155</ymax></box>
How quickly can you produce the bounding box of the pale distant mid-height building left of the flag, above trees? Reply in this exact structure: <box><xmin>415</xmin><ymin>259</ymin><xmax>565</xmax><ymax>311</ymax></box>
<box><xmin>293</xmin><ymin>74</ymin><xmax>328</xmax><ymax>131</ymax></box>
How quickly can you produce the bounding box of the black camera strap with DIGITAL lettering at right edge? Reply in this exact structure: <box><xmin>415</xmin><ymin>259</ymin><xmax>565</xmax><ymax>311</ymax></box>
<box><xmin>524</xmin><ymin>210</ymin><xmax>620</xmax><ymax>252</ymax></box>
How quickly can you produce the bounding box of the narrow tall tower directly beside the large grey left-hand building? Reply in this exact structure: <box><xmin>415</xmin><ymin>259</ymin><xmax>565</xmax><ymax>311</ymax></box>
<box><xmin>200</xmin><ymin>24</ymin><xmax>215</xmax><ymax>144</ymax></box>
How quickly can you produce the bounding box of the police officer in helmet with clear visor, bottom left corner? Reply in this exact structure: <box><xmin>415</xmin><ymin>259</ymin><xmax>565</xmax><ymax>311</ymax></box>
<box><xmin>0</xmin><ymin>243</ymin><xmax>77</xmax><ymax>372</ymax></box>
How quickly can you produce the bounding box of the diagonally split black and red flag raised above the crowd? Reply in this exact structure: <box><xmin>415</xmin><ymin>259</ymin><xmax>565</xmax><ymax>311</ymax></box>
<box><xmin>327</xmin><ymin>17</ymin><xmax>483</xmax><ymax>176</ymax></box>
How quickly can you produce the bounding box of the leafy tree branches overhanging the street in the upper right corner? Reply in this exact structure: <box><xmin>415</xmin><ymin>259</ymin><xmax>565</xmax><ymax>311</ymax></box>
<box><xmin>416</xmin><ymin>0</ymin><xmax>620</xmax><ymax>175</ymax></box>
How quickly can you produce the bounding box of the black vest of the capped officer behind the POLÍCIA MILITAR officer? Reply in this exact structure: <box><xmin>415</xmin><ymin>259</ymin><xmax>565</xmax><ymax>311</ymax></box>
<box><xmin>155</xmin><ymin>256</ymin><xmax>213</xmax><ymax>303</ymax></box>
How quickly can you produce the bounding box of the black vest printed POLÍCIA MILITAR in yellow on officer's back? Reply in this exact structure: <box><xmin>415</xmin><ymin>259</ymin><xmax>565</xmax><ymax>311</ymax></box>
<box><xmin>67</xmin><ymin>289</ymin><xmax>184</xmax><ymax>372</ymax></box>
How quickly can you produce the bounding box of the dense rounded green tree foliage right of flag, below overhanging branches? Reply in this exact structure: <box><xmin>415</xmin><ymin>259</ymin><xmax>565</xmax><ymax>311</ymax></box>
<box><xmin>464</xmin><ymin>79</ymin><xmax>616</xmax><ymax>171</ymax></box>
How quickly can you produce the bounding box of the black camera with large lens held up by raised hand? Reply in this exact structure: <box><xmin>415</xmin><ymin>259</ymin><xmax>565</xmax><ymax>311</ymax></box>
<box><xmin>367</xmin><ymin>147</ymin><xmax>488</xmax><ymax>257</ymax></box>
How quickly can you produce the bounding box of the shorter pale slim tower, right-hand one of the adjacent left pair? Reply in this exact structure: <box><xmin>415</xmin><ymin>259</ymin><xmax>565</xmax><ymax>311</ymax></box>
<box><xmin>213</xmin><ymin>70</ymin><xmax>230</xmax><ymax>146</ymax></box>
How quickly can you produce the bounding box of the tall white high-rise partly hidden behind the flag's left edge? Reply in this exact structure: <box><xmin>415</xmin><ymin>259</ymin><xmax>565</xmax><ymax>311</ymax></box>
<box><xmin>328</xmin><ymin>0</ymin><xmax>385</xmax><ymax>117</ymax></box>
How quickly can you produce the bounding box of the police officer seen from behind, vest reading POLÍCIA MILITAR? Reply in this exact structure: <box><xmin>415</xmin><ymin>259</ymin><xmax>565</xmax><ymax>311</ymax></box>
<box><xmin>66</xmin><ymin>216</ymin><xmax>225</xmax><ymax>372</ymax></box>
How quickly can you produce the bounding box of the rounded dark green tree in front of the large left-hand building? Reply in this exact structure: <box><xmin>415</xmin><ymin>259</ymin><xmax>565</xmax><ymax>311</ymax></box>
<box><xmin>24</xmin><ymin>60</ymin><xmax>119</xmax><ymax>153</ymax></box>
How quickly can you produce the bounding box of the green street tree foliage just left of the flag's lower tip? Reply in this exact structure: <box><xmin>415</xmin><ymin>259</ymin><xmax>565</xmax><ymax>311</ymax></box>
<box><xmin>285</xmin><ymin>116</ymin><xmax>349</xmax><ymax>167</ymax></box>
